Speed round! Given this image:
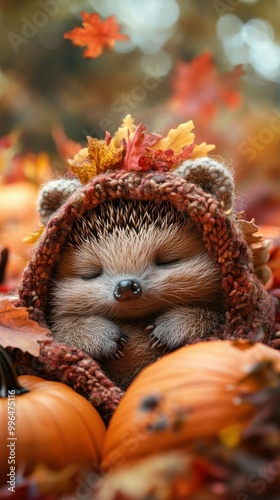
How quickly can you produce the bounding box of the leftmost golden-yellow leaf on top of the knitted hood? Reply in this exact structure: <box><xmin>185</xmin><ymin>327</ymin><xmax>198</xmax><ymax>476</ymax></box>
<box><xmin>68</xmin><ymin>137</ymin><xmax>125</xmax><ymax>184</ymax></box>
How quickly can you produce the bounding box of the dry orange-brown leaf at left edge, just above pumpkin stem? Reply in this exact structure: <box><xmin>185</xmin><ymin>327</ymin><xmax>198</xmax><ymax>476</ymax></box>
<box><xmin>0</xmin><ymin>298</ymin><xmax>50</xmax><ymax>356</ymax></box>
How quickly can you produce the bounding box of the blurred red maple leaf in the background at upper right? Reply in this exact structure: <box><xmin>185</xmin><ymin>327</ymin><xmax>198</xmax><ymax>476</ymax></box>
<box><xmin>169</xmin><ymin>51</ymin><xmax>243</xmax><ymax>123</ymax></box>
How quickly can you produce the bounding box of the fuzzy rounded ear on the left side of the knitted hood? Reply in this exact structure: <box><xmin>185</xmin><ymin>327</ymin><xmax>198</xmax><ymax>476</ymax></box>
<box><xmin>37</xmin><ymin>179</ymin><xmax>81</xmax><ymax>225</ymax></box>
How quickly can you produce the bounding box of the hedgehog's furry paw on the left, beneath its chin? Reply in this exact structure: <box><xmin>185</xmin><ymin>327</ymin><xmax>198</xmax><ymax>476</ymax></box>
<box><xmin>52</xmin><ymin>315</ymin><xmax>127</xmax><ymax>360</ymax></box>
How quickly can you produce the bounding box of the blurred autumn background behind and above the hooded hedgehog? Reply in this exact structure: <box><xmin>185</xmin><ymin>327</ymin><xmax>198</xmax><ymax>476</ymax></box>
<box><xmin>0</xmin><ymin>0</ymin><xmax>280</xmax><ymax>289</ymax></box>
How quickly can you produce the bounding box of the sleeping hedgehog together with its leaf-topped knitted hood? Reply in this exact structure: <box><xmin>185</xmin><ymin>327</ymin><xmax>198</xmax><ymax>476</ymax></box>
<box><xmin>17</xmin><ymin>115</ymin><xmax>274</xmax><ymax>398</ymax></box>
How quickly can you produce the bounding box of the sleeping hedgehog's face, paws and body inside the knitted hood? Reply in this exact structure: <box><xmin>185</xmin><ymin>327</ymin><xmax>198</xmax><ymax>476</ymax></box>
<box><xmin>48</xmin><ymin>200</ymin><xmax>224</xmax><ymax>388</ymax></box>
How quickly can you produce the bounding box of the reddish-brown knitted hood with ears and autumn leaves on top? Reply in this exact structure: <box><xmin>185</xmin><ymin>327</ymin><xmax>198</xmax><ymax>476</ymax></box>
<box><xmin>16</xmin><ymin>116</ymin><xmax>274</xmax><ymax>419</ymax></box>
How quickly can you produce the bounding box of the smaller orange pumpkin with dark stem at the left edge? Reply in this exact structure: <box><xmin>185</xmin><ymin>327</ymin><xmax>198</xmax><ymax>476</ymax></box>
<box><xmin>0</xmin><ymin>348</ymin><xmax>105</xmax><ymax>484</ymax></box>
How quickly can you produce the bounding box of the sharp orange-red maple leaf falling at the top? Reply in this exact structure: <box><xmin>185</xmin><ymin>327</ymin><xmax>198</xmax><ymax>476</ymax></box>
<box><xmin>64</xmin><ymin>12</ymin><xmax>128</xmax><ymax>58</ymax></box>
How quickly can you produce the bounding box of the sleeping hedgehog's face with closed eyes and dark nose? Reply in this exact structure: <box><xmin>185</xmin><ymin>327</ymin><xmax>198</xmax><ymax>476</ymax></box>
<box><xmin>49</xmin><ymin>202</ymin><xmax>221</xmax><ymax>321</ymax></box>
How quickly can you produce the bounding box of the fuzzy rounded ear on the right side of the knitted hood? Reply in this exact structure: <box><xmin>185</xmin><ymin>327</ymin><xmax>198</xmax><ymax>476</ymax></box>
<box><xmin>174</xmin><ymin>156</ymin><xmax>234</xmax><ymax>210</ymax></box>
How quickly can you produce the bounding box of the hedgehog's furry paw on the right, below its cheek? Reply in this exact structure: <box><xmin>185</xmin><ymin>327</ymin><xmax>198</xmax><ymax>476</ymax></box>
<box><xmin>150</xmin><ymin>306</ymin><xmax>223</xmax><ymax>351</ymax></box>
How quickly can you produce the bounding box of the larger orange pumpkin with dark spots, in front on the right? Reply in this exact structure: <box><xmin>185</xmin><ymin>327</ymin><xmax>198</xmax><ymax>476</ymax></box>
<box><xmin>103</xmin><ymin>341</ymin><xmax>280</xmax><ymax>470</ymax></box>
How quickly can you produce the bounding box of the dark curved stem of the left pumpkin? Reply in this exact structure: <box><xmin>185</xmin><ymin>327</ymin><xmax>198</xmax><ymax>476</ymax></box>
<box><xmin>0</xmin><ymin>346</ymin><xmax>29</xmax><ymax>398</ymax></box>
